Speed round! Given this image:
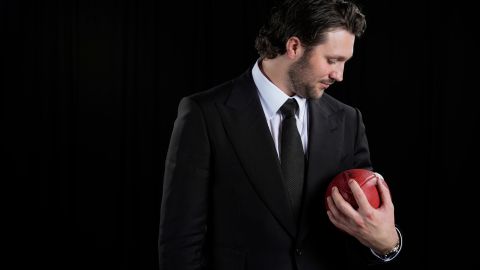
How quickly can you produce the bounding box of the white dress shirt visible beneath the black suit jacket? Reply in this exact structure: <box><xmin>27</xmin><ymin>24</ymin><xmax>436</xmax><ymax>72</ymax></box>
<box><xmin>252</xmin><ymin>61</ymin><xmax>308</xmax><ymax>157</ymax></box>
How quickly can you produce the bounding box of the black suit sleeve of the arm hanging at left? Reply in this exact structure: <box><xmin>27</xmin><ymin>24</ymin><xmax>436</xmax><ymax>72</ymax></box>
<box><xmin>158</xmin><ymin>97</ymin><xmax>210</xmax><ymax>270</ymax></box>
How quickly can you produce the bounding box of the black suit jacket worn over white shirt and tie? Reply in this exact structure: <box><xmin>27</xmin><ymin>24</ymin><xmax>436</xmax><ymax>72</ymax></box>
<box><xmin>159</xmin><ymin>70</ymin><xmax>371</xmax><ymax>270</ymax></box>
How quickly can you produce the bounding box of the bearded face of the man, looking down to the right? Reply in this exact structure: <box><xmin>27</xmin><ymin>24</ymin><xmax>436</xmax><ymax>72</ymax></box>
<box><xmin>288</xmin><ymin>29</ymin><xmax>355</xmax><ymax>99</ymax></box>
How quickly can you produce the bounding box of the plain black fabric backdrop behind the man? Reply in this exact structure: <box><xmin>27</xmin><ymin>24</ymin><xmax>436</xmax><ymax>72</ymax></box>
<box><xmin>0</xmin><ymin>0</ymin><xmax>479</xmax><ymax>269</ymax></box>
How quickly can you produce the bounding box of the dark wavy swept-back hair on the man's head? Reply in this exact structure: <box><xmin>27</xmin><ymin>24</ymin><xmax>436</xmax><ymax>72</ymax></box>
<box><xmin>255</xmin><ymin>0</ymin><xmax>367</xmax><ymax>59</ymax></box>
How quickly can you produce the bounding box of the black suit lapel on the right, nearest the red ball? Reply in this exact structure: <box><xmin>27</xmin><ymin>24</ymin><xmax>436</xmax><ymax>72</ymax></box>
<box><xmin>299</xmin><ymin>98</ymin><xmax>343</xmax><ymax>240</ymax></box>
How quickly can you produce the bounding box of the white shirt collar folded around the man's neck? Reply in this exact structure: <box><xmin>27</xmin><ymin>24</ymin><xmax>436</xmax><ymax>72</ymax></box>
<box><xmin>252</xmin><ymin>60</ymin><xmax>307</xmax><ymax>119</ymax></box>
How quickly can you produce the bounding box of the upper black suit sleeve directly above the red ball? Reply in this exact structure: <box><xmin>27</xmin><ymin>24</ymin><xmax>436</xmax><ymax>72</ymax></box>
<box><xmin>353</xmin><ymin>108</ymin><xmax>373</xmax><ymax>170</ymax></box>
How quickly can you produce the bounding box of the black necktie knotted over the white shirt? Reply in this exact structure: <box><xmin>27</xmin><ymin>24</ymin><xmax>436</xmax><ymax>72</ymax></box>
<box><xmin>280</xmin><ymin>98</ymin><xmax>305</xmax><ymax>219</ymax></box>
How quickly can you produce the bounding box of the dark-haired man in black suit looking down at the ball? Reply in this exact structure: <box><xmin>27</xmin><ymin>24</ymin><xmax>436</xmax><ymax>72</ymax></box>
<box><xmin>159</xmin><ymin>0</ymin><xmax>401</xmax><ymax>270</ymax></box>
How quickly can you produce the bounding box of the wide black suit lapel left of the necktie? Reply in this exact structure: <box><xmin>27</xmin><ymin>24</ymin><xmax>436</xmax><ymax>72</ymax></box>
<box><xmin>217</xmin><ymin>70</ymin><xmax>295</xmax><ymax>237</ymax></box>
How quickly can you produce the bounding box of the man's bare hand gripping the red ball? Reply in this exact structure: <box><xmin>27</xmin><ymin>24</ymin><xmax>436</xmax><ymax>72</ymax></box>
<box><xmin>327</xmin><ymin>174</ymin><xmax>399</xmax><ymax>254</ymax></box>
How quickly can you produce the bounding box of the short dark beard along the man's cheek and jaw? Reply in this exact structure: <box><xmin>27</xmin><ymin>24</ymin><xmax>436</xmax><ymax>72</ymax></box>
<box><xmin>288</xmin><ymin>51</ymin><xmax>330</xmax><ymax>99</ymax></box>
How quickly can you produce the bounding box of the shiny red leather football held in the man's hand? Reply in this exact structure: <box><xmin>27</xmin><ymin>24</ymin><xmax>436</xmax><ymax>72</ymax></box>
<box><xmin>325</xmin><ymin>169</ymin><xmax>381</xmax><ymax>210</ymax></box>
